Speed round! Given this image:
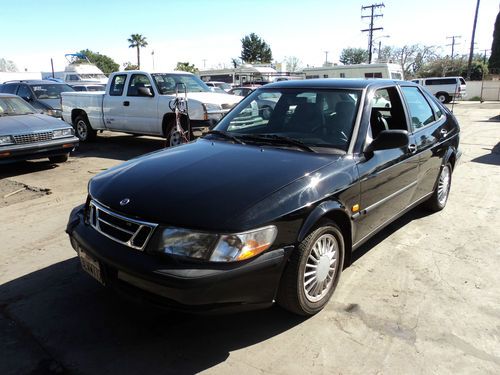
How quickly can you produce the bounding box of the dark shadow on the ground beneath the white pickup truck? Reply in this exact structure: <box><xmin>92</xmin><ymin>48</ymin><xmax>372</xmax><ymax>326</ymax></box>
<box><xmin>71</xmin><ymin>132</ymin><xmax>165</xmax><ymax>160</ymax></box>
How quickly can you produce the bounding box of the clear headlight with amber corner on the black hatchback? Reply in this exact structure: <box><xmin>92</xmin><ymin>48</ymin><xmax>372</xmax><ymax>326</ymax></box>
<box><xmin>158</xmin><ymin>225</ymin><xmax>278</xmax><ymax>262</ymax></box>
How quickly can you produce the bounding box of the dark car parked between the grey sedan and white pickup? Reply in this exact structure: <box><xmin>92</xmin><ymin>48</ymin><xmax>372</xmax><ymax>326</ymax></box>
<box><xmin>0</xmin><ymin>80</ymin><xmax>75</xmax><ymax>118</ymax></box>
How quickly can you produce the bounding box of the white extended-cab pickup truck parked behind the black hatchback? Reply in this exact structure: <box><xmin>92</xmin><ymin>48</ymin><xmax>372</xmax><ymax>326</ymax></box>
<box><xmin>61</xmin><ymin>70</ymin><xmax>242</xmax><ymax>146</ymax></box>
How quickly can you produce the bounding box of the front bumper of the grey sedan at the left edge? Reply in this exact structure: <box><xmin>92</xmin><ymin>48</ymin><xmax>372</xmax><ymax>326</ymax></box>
<box><xmin>0</xmin><ymin>137</ymin><xmax>79</xmax><ymax>163</ymax></box>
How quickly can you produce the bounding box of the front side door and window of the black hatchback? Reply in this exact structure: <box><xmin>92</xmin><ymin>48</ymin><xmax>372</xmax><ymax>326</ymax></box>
<box><xmin>354</xmin><ymin>86</ymin><xmax>418</xmax><ymax>244</ymax></box>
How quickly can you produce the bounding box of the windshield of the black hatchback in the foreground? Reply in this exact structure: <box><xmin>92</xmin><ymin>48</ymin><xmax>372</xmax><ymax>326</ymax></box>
<box><xmin>215</xmin><ymin>89</ymin><xmax>361</xmax><ymax>151</ymax></box>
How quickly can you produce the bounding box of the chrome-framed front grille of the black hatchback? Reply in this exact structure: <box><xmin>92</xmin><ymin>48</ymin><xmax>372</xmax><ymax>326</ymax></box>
<box><xmin>89</xmin><ymin>201</ymin><xmax>157</xmax><ymax>250</ymax></box>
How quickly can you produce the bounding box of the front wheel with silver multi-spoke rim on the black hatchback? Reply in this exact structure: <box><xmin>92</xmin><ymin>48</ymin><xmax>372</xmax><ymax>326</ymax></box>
<box><xmin>277</xmin><ymin>220</ymin><xmax>345</xmax><ymax>316</ymax></box>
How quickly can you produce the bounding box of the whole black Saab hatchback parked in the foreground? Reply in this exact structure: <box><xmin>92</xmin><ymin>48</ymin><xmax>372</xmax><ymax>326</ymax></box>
<box><xmin>66</xmin><ymin>79</ymin><xmax>460</xmax><ymax>315</ymax></box>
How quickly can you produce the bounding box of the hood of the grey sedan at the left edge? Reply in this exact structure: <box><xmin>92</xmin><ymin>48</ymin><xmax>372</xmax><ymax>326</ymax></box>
<box><xmin>0</xmin><ymin>114</ymin><xmax>70</xmax><ymax>135</ymax></box>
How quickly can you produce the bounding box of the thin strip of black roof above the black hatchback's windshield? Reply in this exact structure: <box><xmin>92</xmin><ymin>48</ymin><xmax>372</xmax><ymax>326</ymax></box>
<box><xmin>262</xmin><ymin>78</ymin><xmax>415</xmax><ymax>90</ymax></box>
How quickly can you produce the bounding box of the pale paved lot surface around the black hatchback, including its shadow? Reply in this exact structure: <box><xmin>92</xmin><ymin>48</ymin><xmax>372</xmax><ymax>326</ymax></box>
<box><xmin>0</xmin><ymin>103</ymin><xmax>500</xmax><ymax>374</ymax></box>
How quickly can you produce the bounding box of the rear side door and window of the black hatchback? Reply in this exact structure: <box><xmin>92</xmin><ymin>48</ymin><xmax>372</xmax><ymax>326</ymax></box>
<box><xmin>401</xmin><ymin>86</ymin><xmax>451</xmax><ymax>201</ymax></box>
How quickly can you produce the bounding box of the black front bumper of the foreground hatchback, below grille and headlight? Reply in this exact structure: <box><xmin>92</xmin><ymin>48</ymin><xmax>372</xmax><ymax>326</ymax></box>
<box><xmin>66</xmin><ymin>206</ymin><xmax>293</xmax><ymax>312</ymax></box>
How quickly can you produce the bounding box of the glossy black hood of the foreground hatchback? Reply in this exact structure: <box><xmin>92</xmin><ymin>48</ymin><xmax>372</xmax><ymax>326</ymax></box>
<box><xmin>89</xmin><ymin>139</ymin><xmax>339</xmax><ymax>231</ymax></box>
